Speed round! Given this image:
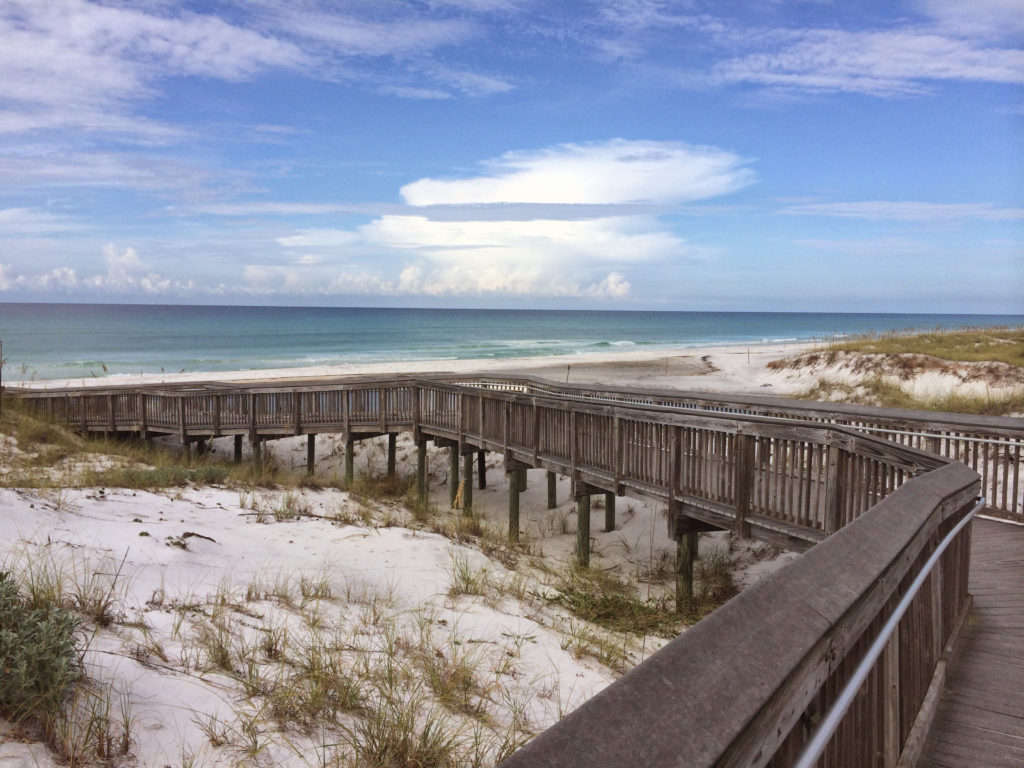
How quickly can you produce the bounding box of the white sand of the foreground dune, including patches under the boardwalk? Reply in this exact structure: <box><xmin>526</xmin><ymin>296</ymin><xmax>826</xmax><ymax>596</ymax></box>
<box><xmin>0</xmin><ymin>411</ymin><xmax>794</xmax><ymax>768</ymax></box>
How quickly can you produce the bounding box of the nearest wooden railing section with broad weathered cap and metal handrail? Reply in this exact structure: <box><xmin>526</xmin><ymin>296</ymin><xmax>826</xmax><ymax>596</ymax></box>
<box><xmin>502</xmin><ymin>464</ymin><xmax>979</xmax><ymax>768</ymax></box>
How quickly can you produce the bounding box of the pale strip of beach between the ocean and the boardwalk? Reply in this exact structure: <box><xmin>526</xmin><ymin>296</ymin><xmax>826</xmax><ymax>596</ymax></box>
<box><xmin>4</xmin><ymin>341</ymin><xmax>820</xmax><ymax>394</ymax></box>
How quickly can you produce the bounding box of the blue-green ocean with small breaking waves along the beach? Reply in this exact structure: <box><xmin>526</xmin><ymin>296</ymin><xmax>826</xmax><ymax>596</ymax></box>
<box><xmin>0</xmin><ymin>303</ymin><xmax>1024</xmax><ymax>381</ymax></box>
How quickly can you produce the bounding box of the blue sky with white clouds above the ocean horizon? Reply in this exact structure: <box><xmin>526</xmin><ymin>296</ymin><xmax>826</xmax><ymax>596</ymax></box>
<box><xmin>0</xmin><ymin>0</ymin><xmax>1024</xmax><ymax>313</ymax></box>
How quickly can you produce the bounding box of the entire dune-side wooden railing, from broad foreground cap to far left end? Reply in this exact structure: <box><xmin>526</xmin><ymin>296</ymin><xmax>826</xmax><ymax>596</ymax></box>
<box><xmin>8</xmin><ymin>378</ymin><xmax>995</xmax><ymax>768</ymax></box>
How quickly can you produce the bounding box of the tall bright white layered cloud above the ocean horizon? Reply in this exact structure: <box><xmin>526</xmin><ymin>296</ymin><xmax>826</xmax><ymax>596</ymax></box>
<box><xmin>246</xmin><ymin>139</ymin><xmax>754</xmax><ymax>298</ymax></box>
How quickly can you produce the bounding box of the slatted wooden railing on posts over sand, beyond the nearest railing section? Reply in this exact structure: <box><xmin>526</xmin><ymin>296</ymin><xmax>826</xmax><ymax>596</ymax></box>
<box><xmin>9</xmin><ymin>379</ymin><xmax>945</xmax><ymax>549</ymax></box>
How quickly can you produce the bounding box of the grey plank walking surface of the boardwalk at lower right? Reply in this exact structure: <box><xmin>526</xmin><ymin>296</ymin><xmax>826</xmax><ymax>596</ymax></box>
<box><xmin>918</xmin><ymin>520</ymin><xmax>1024</xmax><ymax>768</ymax></box>
